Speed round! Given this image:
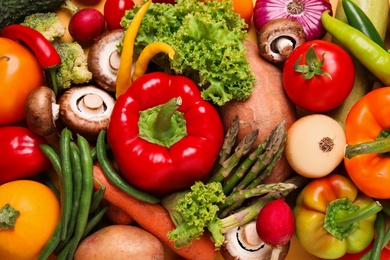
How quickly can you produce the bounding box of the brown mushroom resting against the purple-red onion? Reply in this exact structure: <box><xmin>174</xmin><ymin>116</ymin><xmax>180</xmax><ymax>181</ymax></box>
<box><xmin>257</xmin><ymin>18</ymin><xmax>306</xmax><ymax>63</ymax></box>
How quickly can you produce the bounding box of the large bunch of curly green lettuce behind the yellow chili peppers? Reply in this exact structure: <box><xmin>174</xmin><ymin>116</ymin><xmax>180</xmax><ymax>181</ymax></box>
<box><xmin>121</xmin><ymin>0</ymin><xmax>255</xmax><ymax>106</ymax></box>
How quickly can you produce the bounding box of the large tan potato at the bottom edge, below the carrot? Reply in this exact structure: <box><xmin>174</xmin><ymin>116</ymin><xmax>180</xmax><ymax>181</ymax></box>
<box><xmin>74</xmin><ymin>225</ymin><xmax>164</xmax><ymax>260</ymax></box>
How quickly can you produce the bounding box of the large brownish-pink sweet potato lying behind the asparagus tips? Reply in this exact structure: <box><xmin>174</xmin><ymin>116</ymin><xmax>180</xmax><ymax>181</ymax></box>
<box><xmin>218</xmin><ymin>41</ymin><xmax>297</xmax><ymax>183</ymax></box>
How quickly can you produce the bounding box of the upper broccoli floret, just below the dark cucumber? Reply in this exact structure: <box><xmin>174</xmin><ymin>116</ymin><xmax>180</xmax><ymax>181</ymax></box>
<box><xmin>21</xmin><ymin>12</ymin><xmax>66</xmax><ymax>42</ymax></box>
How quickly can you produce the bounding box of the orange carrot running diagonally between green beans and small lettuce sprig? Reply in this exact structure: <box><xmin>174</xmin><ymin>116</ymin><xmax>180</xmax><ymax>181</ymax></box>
<box><xmin>93</xmin><ymin>165</ymin><xmax>217</xmax><ymax>260</ymax></box>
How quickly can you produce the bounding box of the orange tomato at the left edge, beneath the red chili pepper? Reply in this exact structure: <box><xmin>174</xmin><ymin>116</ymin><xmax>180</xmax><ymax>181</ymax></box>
<box><xmin>0</xmin><ymin>37</ymin><xmax>43</xmax><ymax>125</ymax></box>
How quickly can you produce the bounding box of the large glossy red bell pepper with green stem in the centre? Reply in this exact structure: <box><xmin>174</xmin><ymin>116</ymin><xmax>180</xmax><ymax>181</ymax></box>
<box><xmin>107</xmin><ymin>72</ymin><xmax>224</xmax><ymax>196</ymax></box>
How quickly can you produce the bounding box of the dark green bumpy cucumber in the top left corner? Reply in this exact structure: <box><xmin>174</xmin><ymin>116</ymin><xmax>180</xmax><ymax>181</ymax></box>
<box><xmin>0</xmin><ymin>0</ymin><xmax>65</xmax><ymax>30</ymax></box>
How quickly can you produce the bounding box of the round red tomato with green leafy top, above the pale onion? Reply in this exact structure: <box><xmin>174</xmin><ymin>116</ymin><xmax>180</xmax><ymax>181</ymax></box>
<box><xmin>283</xmin><ymin>40</ymin><xmax>355</xmax><ymax>112</ymax></box>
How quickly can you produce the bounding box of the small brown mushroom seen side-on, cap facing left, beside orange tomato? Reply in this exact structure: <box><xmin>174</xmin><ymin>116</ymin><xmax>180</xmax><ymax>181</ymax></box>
<box><xmin>24</xmin><ymin>86</ymin><xmax>59</xmax><ymax>136</ymax></box>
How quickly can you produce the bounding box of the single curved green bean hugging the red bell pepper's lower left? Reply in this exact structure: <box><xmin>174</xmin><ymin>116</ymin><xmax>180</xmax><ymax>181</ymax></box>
<box><xmin>96</xmin><ymin>130</ymin><xmax>160</xmax><ymax>203</ymax></box>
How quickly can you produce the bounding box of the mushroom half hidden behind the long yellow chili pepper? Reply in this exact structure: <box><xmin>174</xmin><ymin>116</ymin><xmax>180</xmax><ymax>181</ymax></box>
<box><xmin>88</xmin><ymin>29</ymin><xmax>125</xmax><ymax>92</ymax></box>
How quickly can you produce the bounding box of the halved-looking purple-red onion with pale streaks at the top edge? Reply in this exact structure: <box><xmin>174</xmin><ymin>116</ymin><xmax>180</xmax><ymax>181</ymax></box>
<box><xmin>253</xmin><ymin>0</ymin><xmax>332</xmax><ymax>41</ymax></box>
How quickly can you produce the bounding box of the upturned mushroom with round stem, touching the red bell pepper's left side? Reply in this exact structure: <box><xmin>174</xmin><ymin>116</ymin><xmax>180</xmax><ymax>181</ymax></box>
<box><xmin>59</xmin><ymin>85</ymin><xmax>115</xmax><ymax>140</ymax></box>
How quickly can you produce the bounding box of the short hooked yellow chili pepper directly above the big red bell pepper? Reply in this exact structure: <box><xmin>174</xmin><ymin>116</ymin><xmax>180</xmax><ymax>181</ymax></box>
<box><xmin>133</xmin><ymin>42</ymin><xmax>175</xmax><ymax>81</ymax></box>
